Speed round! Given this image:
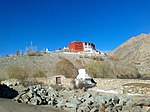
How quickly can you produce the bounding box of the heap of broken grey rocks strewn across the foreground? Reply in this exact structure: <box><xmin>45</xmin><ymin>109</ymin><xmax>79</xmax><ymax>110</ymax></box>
<box><xmin>14</xmin><ymin>85</ymin><xmax>149</xmax><ymax>112</ymax></box>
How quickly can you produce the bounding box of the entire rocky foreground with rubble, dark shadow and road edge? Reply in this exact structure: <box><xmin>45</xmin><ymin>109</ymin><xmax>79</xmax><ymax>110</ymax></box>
<box><xmin>0</xmin><ymin>78</ymin><xmax>150</xmax><ymax>112</ymax></box>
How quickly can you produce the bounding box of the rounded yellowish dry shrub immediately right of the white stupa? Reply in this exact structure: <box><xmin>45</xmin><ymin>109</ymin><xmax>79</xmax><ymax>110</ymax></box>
<box><xmin>85</xmin><ymin>61</ymin><xmax>113</xmax><ymax>78</ymax></box>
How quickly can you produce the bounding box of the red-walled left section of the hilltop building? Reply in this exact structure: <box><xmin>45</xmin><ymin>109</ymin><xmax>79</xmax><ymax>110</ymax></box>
<box><xmin>68</xmin><ymin>42</ymin><xmax>84</xmax><ymax>52</ymax></box>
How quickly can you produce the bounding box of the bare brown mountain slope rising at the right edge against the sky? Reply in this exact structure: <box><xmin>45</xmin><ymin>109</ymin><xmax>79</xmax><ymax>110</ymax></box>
<box><xmin>110</xmin><ymin>34</ymin><xmax>150</xmax><ymax>72</ymax></box>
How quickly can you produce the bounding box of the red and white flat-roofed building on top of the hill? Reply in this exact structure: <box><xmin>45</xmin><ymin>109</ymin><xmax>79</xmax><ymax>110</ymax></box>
<box><xmin>68</xmin><ymin>41</ymin><xmax>95</xmax><ymax>52</ymax></box>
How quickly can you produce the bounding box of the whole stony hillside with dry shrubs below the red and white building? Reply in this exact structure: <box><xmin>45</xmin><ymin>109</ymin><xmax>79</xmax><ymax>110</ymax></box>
<box><xmin>0</xmin><ymin>52</ymin><xmax>141</xmax><ymax>81</ymax></box>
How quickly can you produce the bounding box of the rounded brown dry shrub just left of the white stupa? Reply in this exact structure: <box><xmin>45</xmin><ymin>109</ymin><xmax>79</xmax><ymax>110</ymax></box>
<box><xmin>56</xmin><ymin>59</ymin><xmax>77</xmax><ymax>78</ymax></box>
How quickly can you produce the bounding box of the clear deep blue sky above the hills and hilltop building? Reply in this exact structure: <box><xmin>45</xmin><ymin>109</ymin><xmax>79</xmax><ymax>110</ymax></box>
<box><xmin>0</xmin><ymin>0</ymin><xmax>150</xmax><ymax>55</ymax></box>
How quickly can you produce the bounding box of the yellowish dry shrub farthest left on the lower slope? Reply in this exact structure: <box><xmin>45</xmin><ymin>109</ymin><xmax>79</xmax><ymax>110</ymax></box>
<box><xmin>7</xmin><ymin>66</ymin><xmax>28</xmax><ymax>82</ymax></box>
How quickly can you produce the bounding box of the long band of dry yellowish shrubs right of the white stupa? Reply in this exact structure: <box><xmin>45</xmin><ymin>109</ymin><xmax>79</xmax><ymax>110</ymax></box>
<box><xmin>86</xmin><ymin>60</ymin><xmax>142</xmax><ymax>79</ymax></box>
